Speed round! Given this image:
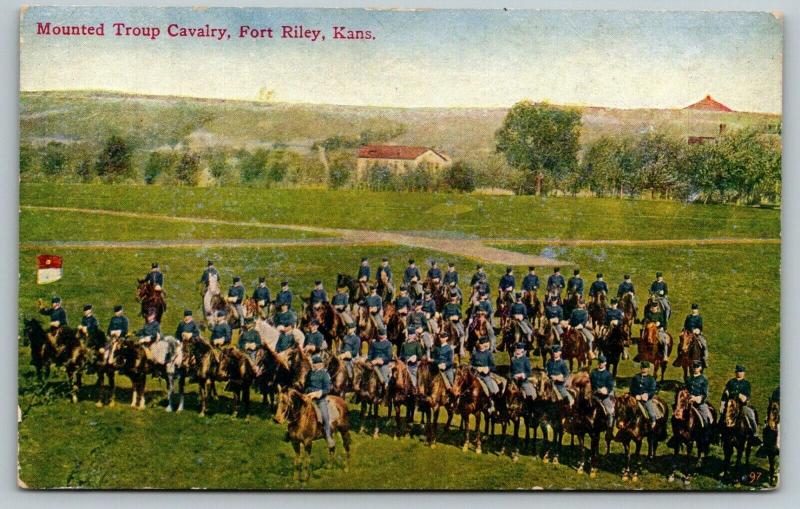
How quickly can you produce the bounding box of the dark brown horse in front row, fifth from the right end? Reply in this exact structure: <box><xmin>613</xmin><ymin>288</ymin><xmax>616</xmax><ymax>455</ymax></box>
<box><xmin>561</xmin><ymin>372</ymin><xmax>611</xmax><ymax>478</ymax></box>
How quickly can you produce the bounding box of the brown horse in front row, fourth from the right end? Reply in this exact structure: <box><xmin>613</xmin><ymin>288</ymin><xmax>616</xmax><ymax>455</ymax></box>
<box><xmin>614</xmin><ymin>393</ymin><xmax>668</xmax><ymax>482</ymax></box>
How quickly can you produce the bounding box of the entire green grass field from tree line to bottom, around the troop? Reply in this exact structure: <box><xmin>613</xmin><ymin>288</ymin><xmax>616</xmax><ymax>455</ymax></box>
<box><xmin>19</xmin><ymin>183</ymin><xmax>781</xmax><ymax>490</ymax></box>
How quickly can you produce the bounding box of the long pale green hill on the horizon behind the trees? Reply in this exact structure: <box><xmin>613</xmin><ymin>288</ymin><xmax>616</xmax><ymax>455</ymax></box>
<box><xmin>20</xmin><ymin>91</ymin><xmax>781</xmax><ymax>159</ymax></box>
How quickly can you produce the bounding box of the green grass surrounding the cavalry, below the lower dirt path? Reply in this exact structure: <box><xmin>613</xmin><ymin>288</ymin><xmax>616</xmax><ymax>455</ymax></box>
<box><xmin>20</xmin><ymin>242</ymin><xmax>780</xmax><ymax>489</ymax></box>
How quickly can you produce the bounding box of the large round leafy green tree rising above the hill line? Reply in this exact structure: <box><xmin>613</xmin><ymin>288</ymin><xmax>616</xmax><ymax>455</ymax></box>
<box><xmin>495</xmin><ymin>101</ymin><xmax>581</xmax><ymax>195</ymax></box>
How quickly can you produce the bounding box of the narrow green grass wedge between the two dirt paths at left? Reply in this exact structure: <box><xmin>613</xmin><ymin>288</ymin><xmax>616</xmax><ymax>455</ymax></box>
<box><xmin>19</xmin><ymin>209</ymin><xmax>332</xmax><ymax>242</ymax></box>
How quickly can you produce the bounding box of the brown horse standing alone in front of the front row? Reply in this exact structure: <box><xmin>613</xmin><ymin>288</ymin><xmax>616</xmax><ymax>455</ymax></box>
<box><xmin>274</xmin><ymin>389</ymin><xmax>350</xmax><ymax>481</ymax></box>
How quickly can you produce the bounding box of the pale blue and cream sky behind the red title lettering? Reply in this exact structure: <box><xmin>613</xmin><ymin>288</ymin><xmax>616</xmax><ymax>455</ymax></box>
<box><xmin>20</xmin><ymin>7</ymin><xmax>782</xmax><ymax>112</ymax></box>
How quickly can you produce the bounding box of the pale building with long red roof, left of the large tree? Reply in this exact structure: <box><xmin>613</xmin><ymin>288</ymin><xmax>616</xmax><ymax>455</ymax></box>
<box><xmin>356</xmin><ymin>145</ymin><xmax>452</xmax><ymax>180</ymax></box>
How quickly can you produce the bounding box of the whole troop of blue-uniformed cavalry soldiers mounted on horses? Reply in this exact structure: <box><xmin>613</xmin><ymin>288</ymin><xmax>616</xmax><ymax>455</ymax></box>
<box><xmin>24</xmin><ymin>258</ymin><xmax>780</xmax><ymax>483</ymax></box>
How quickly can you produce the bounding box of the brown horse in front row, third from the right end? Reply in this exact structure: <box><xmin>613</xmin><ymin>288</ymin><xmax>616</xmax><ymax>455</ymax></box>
<box><xmin>667</xmin><ymin>388</ymin><xmax>717</xmax><ymax>484</ymax></box>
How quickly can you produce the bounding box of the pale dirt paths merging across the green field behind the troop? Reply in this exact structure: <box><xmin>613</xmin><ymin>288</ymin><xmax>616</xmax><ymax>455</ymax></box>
<box><xmin>20</xmin><ymin>205</ymin><xmax>781</xmax><ymax>266</ymax></box>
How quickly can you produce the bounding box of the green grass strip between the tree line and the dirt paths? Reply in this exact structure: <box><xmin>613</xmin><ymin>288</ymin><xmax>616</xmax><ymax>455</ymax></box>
<box><xmin>20</xmin><ymin>183</ymin><xmax>780</xmax><ymax>239</ymax></box>
